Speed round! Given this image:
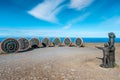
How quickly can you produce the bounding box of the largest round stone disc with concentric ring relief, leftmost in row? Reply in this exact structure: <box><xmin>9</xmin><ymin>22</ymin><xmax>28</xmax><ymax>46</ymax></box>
<box><xmin>1</xmin><ymin>38</ymin><xmax>19</xmax><ymax>53</ymax></box>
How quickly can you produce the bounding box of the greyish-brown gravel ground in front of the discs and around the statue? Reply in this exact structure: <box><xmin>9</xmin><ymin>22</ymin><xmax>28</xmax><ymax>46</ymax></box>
<box><xmin>0</xmin><ymin>44</ymin><xmax>120</xmax><ymax>80</ymax></box>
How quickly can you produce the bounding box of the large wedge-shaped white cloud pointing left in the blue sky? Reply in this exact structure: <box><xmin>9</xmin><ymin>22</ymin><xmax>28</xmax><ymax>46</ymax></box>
<box><xmin>28</xmin><ymin>0</ymin><xmax>64</xmax><ymax>22</ymax></box>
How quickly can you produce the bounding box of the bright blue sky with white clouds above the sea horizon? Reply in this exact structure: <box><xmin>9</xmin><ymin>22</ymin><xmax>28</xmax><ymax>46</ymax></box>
<box><xmin>0</xmin><ymin>0</ymin><xmax>120</xmax><ymax>37</ymax></box>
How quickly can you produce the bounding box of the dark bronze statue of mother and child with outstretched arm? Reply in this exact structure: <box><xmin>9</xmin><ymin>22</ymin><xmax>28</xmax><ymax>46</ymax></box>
<box><xmin>97</xmin><ymin>32</ymin><xmax>115</xmax><ymax>68</ymax></box>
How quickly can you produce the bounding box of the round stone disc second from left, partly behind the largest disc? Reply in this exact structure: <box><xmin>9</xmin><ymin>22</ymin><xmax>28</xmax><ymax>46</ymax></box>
<box><xmin>18</xmin><ymin>38</ymin><xmax>29</xmax><ymax>51</ymax></box>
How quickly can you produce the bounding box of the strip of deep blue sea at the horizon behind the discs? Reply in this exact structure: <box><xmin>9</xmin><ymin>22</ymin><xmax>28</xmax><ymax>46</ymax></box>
<box><xmin>0</xmin><ymin>37</ymin><xmax>120</xmax><ymax>43</ymax></box>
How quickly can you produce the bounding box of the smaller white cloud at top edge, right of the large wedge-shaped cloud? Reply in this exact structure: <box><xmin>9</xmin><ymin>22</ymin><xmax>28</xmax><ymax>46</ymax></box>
<box><xmin>69</xmin><ymin>0</ymin><xmax>94</xmax><ymax>10</ymax></box>
